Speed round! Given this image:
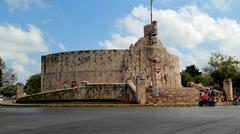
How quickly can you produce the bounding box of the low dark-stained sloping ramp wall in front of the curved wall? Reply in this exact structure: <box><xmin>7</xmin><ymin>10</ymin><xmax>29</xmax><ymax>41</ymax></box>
<box><xmin>17</xmin><ymin>83</ymin><xmax>136</xmax><ymax>103</ymax></box>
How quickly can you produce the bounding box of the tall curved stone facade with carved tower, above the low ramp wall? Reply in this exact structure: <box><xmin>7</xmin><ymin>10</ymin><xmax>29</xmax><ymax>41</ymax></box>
<box><xmin>41</xmin><ymin>22</ymin><xmax>181</xmax><ymax>92</ymax></box>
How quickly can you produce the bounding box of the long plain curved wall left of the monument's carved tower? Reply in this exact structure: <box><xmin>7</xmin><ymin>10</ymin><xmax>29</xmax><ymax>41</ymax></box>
<box><xmin>41</xmin><ymin>50</ymin><xmax>127</xmax><ymax>92</ymax></box>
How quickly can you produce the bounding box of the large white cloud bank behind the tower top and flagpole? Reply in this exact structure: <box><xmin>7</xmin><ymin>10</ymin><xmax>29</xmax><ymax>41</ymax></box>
<box><xmin>99</xmin><ymin>5</ymin><xmax>240</xmax><ymax>67</ymax></box>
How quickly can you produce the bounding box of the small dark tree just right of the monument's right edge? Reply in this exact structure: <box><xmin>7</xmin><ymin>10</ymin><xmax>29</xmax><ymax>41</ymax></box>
<box><xmin>181</xmin><ymin>65</ymin><xmax>202</xmax><ymax>86</ymax></box>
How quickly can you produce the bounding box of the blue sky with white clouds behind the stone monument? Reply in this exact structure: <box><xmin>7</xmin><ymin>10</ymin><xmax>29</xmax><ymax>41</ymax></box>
<box><xmin>0</xmin><ymin>0</ymin><xmax>240</xmax><ymax>83</ymax></box>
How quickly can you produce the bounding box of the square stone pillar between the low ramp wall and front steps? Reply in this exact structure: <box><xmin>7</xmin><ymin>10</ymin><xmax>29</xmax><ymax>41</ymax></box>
<box><xmin>136</xmin><ymin>76</ymin><xmax>146</xmax><ymax>104</ymax></box>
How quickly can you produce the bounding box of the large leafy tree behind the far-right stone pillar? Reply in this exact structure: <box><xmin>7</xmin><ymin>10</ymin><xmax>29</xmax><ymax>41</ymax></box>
<box><xmin>204</xmin><ymin>53</ymin><xmax>240</xmax><ymax>88</ymax></box>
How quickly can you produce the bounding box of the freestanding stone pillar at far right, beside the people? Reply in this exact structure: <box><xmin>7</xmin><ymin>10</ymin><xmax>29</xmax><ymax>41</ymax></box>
<box><xmin>223</xmin><ymin>79</ymin><xmax>233</xmax><ymax>101</ymax></box>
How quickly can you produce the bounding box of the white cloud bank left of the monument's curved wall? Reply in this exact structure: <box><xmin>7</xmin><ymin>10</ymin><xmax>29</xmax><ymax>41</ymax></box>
<box><xmin>0</xmin><ymin>25</ymin><xmax>48</xmax><ymax>82</ymax></box>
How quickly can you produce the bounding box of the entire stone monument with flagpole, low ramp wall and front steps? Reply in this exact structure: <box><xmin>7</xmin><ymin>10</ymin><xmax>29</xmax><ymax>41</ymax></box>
<box><xmin>17</xmin><ymin>0</ymin><xmax>198</xmax><ymax>104</ymax></box>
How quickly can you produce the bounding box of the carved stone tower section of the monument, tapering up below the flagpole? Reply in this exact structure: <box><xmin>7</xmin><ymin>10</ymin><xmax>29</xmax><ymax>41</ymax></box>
<box><xmin>123</xmin><ymin>21</ymin><xmax>181</xmax><ymax>88</ymax></box>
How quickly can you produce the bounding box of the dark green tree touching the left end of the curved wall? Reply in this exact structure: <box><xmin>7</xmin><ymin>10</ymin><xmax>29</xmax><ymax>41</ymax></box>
<box><xmin>24</xmin><ymin>74</ymin><xmax>41</xmax><ymax>94</ymax></box>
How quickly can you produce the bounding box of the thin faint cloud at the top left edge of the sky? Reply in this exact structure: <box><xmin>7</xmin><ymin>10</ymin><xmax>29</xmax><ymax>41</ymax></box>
<box><xmin>4</xmin><ymin>0</ymin><xmax>47</xmax><ymax>11</ymax></box>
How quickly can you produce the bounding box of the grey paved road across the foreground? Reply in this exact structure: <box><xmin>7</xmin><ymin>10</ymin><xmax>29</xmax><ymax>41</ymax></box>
<box><xmin>0</xmin><ymin>107</ymin><xmax>240</xmax><ymax>134</ymax></box>
